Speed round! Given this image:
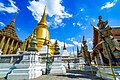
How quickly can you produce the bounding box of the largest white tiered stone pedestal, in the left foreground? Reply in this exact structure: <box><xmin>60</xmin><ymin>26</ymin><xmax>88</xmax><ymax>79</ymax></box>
<box><xmin>7</xmin><ymin>52</ymin><xmax>42</xmax><ymax>80</ymax></box>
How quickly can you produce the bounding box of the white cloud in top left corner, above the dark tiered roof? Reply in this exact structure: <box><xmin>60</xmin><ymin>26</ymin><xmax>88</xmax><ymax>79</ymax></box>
<box><xmin>0</xmin><ymin>0</ymin><xmax>19</xmax><ymax>13</ymax></box>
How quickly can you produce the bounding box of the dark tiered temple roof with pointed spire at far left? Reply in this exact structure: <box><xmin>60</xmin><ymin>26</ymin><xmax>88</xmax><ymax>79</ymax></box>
<box><xmin>0</xmin><ymin>14</ymin><xmax>20</xmax><ymax>41</ymax></box>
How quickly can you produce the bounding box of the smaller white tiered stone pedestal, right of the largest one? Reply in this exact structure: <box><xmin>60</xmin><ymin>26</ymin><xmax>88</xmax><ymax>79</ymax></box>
<box><xmin>50</xmin><ymin>55</ymin><xmax>66</xmax><ymax>75</ymax></box>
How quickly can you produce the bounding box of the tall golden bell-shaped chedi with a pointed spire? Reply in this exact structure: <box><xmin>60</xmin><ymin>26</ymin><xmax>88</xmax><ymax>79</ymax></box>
<box><xmin>35</xmin><ymin>7</ymin><xmax>50</xmax><ymax>50</ymax></box>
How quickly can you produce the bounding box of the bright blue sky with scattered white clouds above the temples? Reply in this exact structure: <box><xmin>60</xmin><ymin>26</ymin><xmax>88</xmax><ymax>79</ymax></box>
<box><xmin>0</xmin><ymin>0</ymin><xmax>120</xmax><ymax>52</ymax></box>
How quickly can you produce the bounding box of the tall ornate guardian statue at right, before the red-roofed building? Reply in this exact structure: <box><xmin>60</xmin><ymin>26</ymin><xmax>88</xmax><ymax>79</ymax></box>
<box><xmin>97</xmin><ymin>16</ymin><xmax>120</xmax><ymax>64</ymax></box>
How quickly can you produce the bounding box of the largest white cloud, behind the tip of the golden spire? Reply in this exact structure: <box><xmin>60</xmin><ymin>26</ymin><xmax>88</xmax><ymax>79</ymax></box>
<box><xmin>27</xmin><ymin>0</ymin><xmax>72</xmax><ymax>28</ymax></box>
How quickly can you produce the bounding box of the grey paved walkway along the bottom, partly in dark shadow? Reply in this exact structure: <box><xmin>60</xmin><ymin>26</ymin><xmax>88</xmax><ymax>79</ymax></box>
<box><xmin>33</xmin><ymin>70</ymin><xmax>100</xmax><ymax>80</ymax></box>
